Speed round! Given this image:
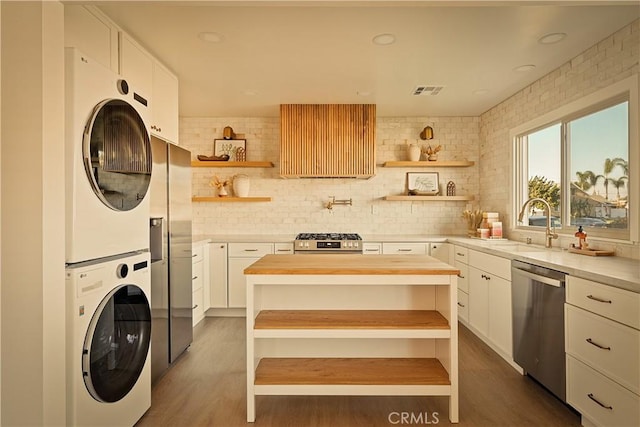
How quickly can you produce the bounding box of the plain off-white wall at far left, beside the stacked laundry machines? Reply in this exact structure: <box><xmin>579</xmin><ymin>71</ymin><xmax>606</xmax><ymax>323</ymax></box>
<box><xmin>0</xmin><ymin>2</ymin><xmax>66</xmax><ymax>425</ymax></box>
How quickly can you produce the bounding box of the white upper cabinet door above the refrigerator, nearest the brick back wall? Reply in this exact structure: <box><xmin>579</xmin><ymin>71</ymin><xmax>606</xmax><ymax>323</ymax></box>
<box><xmin>151</xmin><ymin>61</ymin><xmax>178</xmax><ymax>144</ymax></box>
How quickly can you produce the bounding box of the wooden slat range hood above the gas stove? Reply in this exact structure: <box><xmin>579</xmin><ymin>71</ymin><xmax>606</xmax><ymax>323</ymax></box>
<box><xmin>280</xmin><ymin>104</ymin><xmax>376</xmax><ymax>178</ymax></box>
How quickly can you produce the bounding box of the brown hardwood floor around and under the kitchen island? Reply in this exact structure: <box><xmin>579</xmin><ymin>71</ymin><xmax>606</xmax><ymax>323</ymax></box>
<box><xmin>136</xmin><ymin>318</ymin><xmax>580</xmax><ymax>427</ymax></box>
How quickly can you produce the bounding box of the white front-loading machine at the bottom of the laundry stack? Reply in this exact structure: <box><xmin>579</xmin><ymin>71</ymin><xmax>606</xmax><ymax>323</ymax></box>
<box><xmin>66</xmin><ymin>252</ymin><xmax>151</xmax><ymax>427</ymax></box>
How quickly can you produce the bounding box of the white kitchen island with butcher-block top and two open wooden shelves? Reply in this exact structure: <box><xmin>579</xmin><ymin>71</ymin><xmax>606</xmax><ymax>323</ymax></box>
<box><xmin>244</xmin><ymin>254</ymin><xmax>459</xmax><ymax>423</ymax></box>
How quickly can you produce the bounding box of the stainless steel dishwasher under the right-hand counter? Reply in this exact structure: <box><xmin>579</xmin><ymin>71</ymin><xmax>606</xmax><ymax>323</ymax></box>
<box><xmin>511</xmin><ymin>260</ymin><xmax>566</xmax><ymax>402</ymax></box>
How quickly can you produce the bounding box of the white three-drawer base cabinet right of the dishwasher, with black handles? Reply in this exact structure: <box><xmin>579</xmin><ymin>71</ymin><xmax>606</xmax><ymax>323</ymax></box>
<box><xmin>564</xmin><ymin>276</ymin><xmax>640</xmax><ymax>426</ymax></box>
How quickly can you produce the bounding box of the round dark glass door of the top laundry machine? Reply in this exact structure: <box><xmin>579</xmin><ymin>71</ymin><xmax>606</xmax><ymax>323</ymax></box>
<box><xmin>82</xmin><ymin>99</ymin><xmax>151</xmax><ymax>211</ymax></box>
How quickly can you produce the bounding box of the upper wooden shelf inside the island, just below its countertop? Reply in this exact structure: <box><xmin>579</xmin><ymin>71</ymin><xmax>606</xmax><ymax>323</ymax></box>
<box><xmin>254</xmin><ymin>310</ymin><xmax>449</xmax><ymax>329</ymax></box>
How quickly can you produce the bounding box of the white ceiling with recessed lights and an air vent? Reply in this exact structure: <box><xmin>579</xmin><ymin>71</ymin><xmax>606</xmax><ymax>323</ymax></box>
<box><xmin>94</xmin><ymin>0</ymin><xmax>640</xmax><ymax>117</ymax></box>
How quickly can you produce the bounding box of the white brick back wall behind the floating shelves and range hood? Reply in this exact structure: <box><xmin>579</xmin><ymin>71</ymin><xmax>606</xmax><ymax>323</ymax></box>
<box><xmin>180</xmin><ymin>117</ymin><xmax>480</xmax><ymax>235</ymax></box>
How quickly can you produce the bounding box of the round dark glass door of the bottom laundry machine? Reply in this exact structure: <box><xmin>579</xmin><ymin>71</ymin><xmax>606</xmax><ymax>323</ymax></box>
<box><xmin>82</xmin><ymin>285</ymin><xmax>151</xmax><ymax>402</ymax></box>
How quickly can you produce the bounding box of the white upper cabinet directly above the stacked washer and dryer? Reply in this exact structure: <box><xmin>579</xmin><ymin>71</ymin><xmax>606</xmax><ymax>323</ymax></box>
<box><xmin>64</xmin><ymin>4</ymin><xmax>119</xmax><ymax>73</ymax></box>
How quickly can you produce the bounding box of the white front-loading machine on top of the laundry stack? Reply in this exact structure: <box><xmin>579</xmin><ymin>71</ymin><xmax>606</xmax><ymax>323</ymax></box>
<box><xmin>65</xmin><ymin>48</ymin><xmax>152</xmax><ymax>264</ymax></box>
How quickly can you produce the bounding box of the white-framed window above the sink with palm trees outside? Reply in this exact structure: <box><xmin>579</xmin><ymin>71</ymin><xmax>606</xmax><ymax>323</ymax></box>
<box><xmin>512</xmin><ymin>76</ymin><xmax>638</xmax><ymax>240</ymax></box>
